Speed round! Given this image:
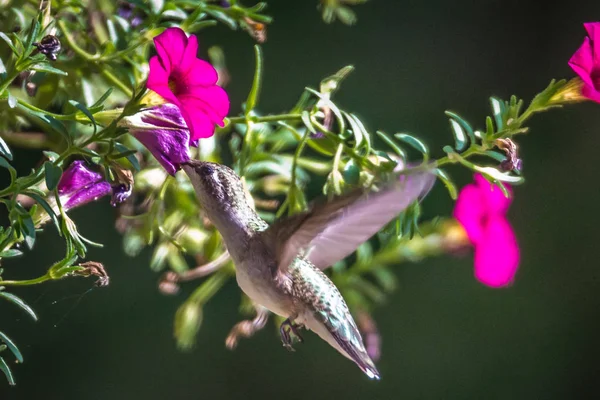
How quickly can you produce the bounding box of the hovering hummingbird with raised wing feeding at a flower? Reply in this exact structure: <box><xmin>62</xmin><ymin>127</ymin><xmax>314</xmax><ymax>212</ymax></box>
<box><xmin>182</xmin><ymin>160</ymin><xmax>435</xmax><ymax>379</ymax></box>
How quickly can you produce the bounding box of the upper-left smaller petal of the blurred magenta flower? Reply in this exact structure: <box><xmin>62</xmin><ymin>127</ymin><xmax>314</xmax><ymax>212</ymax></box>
<box><xmin>453</xmin><ymin>184</ymin><xmax>486</xmax><ymax>244</ymax></box>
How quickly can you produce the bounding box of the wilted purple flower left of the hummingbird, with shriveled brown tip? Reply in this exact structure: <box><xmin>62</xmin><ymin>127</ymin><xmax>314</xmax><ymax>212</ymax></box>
<box><xmin>56</xmin><ymin>160</ymin><xmax>131</xmax><ymax>210</ymax></box>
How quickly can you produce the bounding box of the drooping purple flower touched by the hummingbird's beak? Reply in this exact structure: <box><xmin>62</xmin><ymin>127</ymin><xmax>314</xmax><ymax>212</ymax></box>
<box><xmin>121</xmin><ymin>103</ymin><xmax>190</xmax><ymax>175</ymax></box>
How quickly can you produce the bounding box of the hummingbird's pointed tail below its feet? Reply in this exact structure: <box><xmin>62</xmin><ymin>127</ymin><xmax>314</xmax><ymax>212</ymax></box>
<box><xmin>299</xmin><ymin>314</ymin><xmax>380</xmax><ymax>380</ymax></box>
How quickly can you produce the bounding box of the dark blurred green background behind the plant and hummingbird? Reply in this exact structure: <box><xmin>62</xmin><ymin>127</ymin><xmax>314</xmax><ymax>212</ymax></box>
<box><xmin>0</xmin><ymin>0</ymin><xmax>600</xmax><ymax>400</ymax></box>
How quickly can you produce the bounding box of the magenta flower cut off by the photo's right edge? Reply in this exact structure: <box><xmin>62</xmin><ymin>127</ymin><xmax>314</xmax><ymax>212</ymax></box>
<box><xmin>569</xmin><ymin>22</ymin><xmax>600</xmax><ymax>103</ymax></box>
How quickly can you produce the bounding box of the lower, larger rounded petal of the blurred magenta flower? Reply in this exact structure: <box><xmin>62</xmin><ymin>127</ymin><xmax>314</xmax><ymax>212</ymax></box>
<box><xmin>475</xmin><ymin>216</ymin><xmax>519</xmax><ymax>288</ymax></box>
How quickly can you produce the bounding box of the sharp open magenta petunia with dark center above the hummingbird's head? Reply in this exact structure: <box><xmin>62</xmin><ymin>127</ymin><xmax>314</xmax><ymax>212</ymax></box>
<box><xmin>147</xmin><ymin>28</ymin><xmax>229</xmax><ymax>143</ymax></box>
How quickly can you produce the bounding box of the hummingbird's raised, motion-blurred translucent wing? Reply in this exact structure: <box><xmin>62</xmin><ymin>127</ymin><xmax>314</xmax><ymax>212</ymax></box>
<box><xmin>269</xmin><ymin>171</ymin><xmax>435</xmax><ymax>270</ymax></box>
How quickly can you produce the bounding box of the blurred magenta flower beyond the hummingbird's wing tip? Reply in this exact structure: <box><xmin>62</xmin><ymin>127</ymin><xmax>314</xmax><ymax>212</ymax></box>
<box><xmin>454</xmin><ymin>174</ymin><xmax>519</xmax><ymax>287</ymax></box>
